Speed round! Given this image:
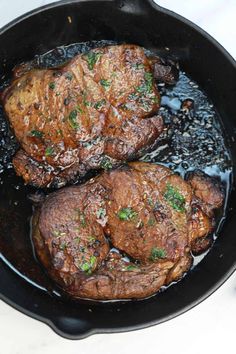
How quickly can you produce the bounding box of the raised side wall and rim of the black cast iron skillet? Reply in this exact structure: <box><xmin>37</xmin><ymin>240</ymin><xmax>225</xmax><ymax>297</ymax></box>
<box><xmin>0</xmin><ymin>0</ymin><xmax>236</xmax><ymax>339</ymax></box>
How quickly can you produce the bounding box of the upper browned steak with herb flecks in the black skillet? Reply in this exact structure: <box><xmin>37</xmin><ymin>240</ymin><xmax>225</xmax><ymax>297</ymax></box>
<box><xmin>2</xmin><ymin>45</ymin><xmax>163</xmax><ymax>187</ymax></box>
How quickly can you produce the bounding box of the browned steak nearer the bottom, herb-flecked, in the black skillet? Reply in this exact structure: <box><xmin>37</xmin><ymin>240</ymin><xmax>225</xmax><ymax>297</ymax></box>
<box><xmin>33</xmin><ymin>162</ymin><xmax>223</xmax><ymax>299</ymax></box>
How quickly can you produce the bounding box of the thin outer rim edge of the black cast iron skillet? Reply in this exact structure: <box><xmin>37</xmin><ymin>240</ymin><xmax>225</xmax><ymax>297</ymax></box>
<box><xmin>0</xmin><ymin>0</ymin><xmax>236</xmax><ymax>339</ymax></box>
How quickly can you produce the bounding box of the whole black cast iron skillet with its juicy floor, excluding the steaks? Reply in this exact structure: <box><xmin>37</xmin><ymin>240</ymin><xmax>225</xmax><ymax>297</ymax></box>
<box><xmin>0</xmin><ymin>0</ymin><xmax>236</xmax><ymax>338</ymax></box>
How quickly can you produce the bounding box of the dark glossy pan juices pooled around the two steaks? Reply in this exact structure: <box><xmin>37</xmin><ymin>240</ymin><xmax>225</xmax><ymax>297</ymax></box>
<box><xmin>0</xmin><ymin>41</ymin><xmax>232</xmax><ymax>297</ymax></box>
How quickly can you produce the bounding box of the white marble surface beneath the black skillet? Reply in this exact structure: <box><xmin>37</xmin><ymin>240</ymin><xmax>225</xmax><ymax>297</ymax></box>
<box><xmin>0</xmin><ymin>0</ymin><xmax>236</xmax><ymax>354</ymax></box>
